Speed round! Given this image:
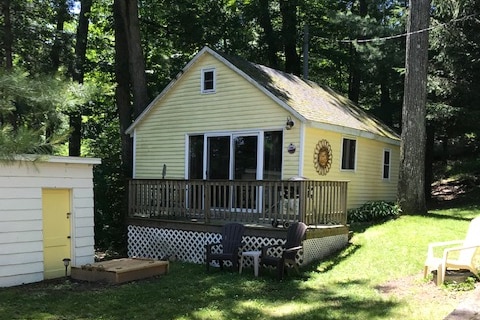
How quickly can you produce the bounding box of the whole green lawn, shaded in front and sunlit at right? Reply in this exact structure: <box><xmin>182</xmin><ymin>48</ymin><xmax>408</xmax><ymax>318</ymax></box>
<box><xmin>0</xmin><ymin>206</ymin><xmax>478</xmax><ymax>320</ymax></box>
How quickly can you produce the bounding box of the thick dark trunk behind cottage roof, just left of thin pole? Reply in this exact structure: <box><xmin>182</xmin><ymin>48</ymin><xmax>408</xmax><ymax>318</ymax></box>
<box><xmin>280</xmin><ymin>0</ymin><xmax>302</xmax><ymax>76</ymax></box>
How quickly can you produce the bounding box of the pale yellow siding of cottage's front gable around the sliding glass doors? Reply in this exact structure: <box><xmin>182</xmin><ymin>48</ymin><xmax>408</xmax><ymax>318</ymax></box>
<box><xmin>135</xmin><ymin>54</ymin><xmax>300</xmax><ymax>179</ymax></box>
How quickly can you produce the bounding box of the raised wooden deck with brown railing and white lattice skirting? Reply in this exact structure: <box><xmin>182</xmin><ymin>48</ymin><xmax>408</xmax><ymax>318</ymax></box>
<box><xmin>127</xmin><ymin>179</ymin><xmax>349</xmax><ymax>264</ymax></box>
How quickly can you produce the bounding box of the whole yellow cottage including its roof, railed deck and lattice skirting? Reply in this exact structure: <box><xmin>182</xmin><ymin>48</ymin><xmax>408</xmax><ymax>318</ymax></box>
<box><xmin>123</xmin><ymin>47</ymin><xmax>400</xmax><ymax>268</ymax></box>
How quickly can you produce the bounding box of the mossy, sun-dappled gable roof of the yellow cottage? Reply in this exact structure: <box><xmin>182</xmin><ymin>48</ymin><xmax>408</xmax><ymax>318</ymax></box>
<box><xmin>126</xmin><ymin>47</ymin><xmax>399</xmax><ymax>140</ymax></box>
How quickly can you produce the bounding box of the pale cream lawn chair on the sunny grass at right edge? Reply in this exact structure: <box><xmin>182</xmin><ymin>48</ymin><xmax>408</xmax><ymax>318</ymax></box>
<box><xmin>423</xmin><ymin>217</ymin><xmax>480</xmax><ymax>285</ymax></box>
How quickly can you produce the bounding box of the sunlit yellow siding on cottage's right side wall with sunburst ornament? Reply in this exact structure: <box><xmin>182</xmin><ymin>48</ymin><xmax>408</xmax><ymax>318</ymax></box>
<box><xmin>303</xmin><ymin>128</ymin><xmax>400</xmax><ymax>208</ymax></box>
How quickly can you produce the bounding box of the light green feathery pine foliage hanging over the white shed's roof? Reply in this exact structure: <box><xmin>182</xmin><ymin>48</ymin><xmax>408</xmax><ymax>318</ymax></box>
<box><xmin>0</xmin><ymin>69</ymin><xmax>96</xmax><ymax>158</ymax></box>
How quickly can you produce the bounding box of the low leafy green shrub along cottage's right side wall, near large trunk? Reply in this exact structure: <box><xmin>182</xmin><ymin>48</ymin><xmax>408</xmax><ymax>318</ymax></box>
<box><xmin>347</xmin><ymin>201</ymin><xmax>401</xmax><ymax>223</ymax></box>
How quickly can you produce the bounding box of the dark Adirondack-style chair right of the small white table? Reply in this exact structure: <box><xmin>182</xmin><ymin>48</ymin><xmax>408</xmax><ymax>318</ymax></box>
<box><xmin>260</xmin><ymin>222</ymin><xmax>307</xmax><ymax>280</ymax></box>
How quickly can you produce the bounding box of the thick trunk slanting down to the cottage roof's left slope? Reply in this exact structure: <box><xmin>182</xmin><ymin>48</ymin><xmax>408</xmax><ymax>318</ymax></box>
<box><xmin>115</xmin><ymin>0</ymin><xmax>149</xmax><ymax>118</ymax></box>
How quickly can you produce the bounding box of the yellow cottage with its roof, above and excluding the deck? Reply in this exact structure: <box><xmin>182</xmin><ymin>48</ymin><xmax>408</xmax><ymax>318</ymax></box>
<box><xmin>127</xmin><ymin>47</ymin><xmax>400</xmax><ymax>208</ymax></box>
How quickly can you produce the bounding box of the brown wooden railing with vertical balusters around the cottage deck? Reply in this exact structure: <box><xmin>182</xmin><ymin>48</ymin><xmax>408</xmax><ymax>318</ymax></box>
<box><xmin>129</xmin><ymin>179</ymin><xmax>347</xmax><ymax>225</ymax></box>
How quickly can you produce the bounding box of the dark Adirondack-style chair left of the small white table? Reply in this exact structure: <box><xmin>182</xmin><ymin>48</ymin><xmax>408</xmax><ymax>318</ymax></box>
<box><xmin>205</xmin><ymin>223</ymin><xmax>245</xmax><ymax>271</ymax></box>
